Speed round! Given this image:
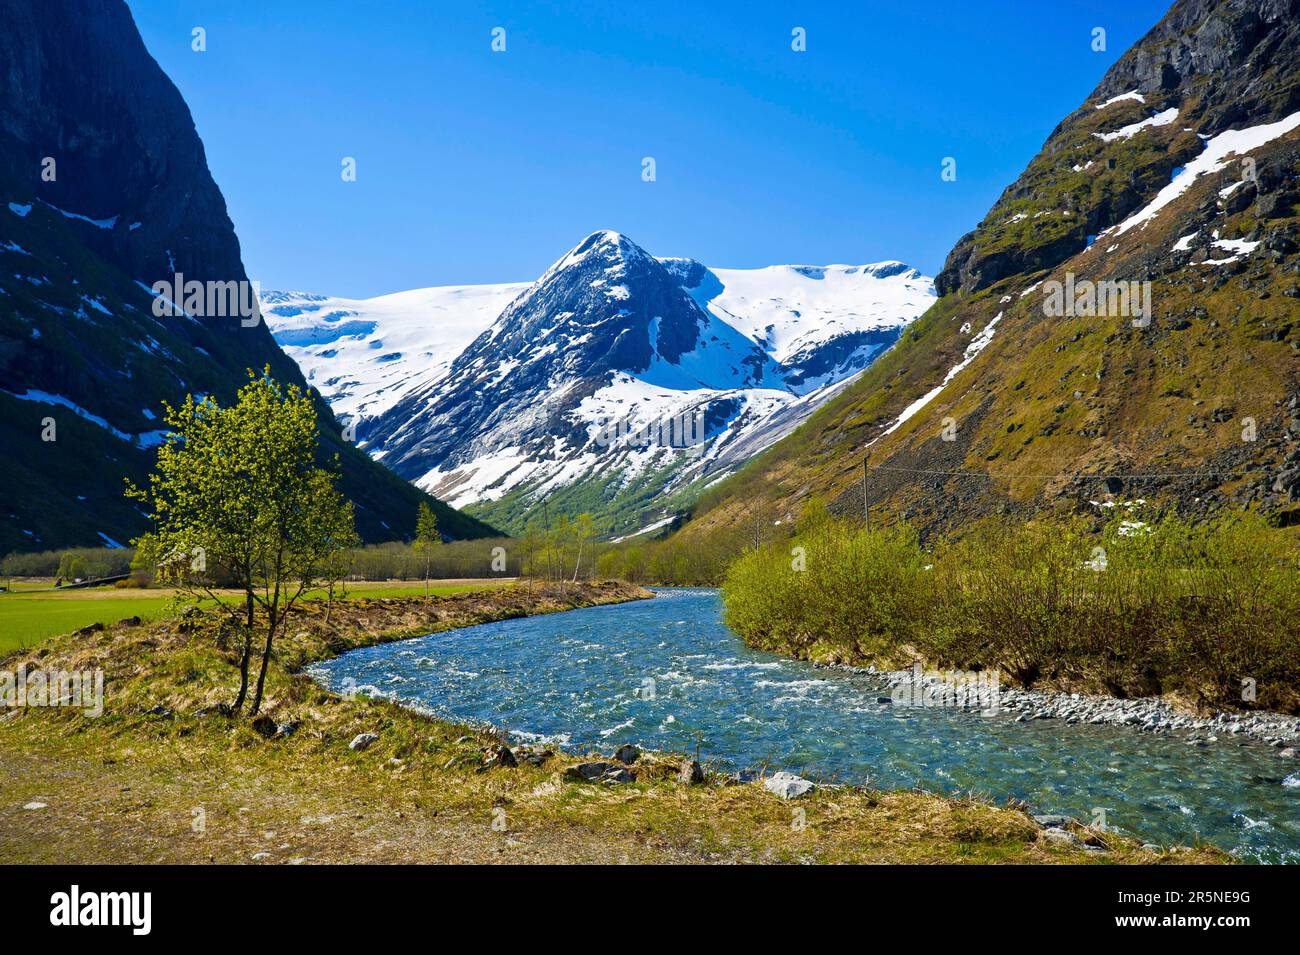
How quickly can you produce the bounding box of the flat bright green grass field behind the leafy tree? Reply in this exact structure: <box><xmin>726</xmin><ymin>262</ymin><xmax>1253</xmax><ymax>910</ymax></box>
<box><xmin>0</xmin><ymin>579</ymin><xmax>503</xmax><ymax>655</ymax></box>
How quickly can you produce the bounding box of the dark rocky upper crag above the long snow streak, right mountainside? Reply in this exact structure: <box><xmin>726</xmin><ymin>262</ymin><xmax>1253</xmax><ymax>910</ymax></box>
<box><xmin>935</xmin><ymin>0</ymin><xmax>1300</xmax><ymax>295</ymax></box>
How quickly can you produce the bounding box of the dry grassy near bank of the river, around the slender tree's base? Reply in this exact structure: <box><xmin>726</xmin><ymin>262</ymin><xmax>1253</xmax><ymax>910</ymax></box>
<box><xmin>0</xmin><ymin>585</ymin><xmax>1229</xmax><ymax>863</ymax></box>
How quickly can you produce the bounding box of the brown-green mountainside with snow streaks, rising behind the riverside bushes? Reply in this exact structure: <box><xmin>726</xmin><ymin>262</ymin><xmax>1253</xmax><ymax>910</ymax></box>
<box><xmin>688</xmin><ymin>0</ymin><xmax>1300</xmax><ymax>533</ymax></box>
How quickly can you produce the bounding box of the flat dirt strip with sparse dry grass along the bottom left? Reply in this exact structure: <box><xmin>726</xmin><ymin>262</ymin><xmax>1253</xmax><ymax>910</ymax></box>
<box><xmin>0</xmin><ymin>750</ymin><xmax>702</xmax><ymax>865</ymax></box>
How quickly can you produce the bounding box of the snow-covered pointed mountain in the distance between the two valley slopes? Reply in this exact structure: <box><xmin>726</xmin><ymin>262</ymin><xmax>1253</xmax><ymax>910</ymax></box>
<box><xmin>263</xmin><ymin>231</ymin><xmax>935</xmax><ymax>533</ymax></box>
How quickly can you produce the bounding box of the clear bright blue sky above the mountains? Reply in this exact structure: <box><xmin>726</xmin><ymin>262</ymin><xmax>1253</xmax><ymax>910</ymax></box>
<box><xmin>129</xmin><ymin>0</ymin><xmax>1167</xmax><ymax>296</ymax></box>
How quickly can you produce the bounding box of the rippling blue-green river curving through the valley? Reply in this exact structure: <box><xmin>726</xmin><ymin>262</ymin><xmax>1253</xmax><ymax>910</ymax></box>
<box><xmin>311</xmin><ymin>590</ymin><xmax>1300</xmax><ymax>863</ymax></box>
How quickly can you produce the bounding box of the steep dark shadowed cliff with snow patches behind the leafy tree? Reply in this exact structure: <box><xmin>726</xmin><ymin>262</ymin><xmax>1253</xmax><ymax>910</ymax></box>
<box><xmin>0</xmin><ymin>0</ymin><xmax>485</xmax><ymax>552</ymax></box>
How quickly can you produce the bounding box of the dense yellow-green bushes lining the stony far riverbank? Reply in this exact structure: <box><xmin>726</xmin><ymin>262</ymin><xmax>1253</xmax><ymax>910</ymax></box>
<box><xmin>723</xmin><ymin>515</ymin><xmax>1300</xmax><ymax>711</ymax></box>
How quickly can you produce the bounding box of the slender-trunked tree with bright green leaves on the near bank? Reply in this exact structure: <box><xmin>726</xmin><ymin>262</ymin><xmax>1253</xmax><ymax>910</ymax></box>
<box><xmin>126</xmin><ymin>366</ymin><xmax>351</xmax><ymax>715</ymax></box>
